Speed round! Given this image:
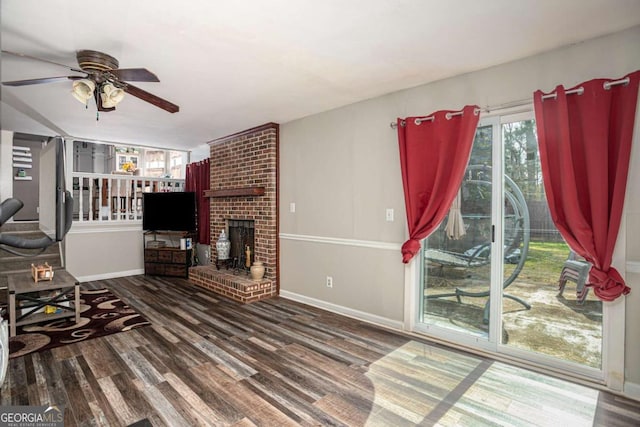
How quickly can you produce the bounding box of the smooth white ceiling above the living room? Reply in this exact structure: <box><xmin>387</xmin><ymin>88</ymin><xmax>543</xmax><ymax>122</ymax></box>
<box><xmin>0</xmin><ymin>0</ymin><xmax>640</xmax><ymax>149</ymax></box>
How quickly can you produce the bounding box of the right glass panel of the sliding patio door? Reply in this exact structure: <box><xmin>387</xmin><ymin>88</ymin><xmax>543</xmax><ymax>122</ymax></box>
<box><xmin>501</xmin><ymin>120</ymin><xmax>602</xmax><ymax>369</ymax></box>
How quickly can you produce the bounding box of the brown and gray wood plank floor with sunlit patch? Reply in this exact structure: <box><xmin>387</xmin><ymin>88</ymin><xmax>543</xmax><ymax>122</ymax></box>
<box><xmin>0</xmin><ymin>276</ymin><xmax>640</xmax><ymax>427</ymax></box>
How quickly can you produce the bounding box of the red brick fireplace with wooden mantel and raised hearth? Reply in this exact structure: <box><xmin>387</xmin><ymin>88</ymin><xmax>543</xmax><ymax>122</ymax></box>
<box><xmin>189</xmin><ymin>123</ymin><xmax>279</xmax><ymax>303</ymax></box>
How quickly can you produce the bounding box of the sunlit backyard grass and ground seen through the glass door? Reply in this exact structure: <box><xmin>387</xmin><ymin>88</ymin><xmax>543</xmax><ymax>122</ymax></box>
<box><xmin>424</xmin><ymin>241</ymin><xmax>602</xmax><ymax>368</ymax></box>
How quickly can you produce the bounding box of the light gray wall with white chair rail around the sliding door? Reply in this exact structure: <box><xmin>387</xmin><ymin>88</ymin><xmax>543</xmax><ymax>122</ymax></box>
<box><xmin>280</xmin><ymin>27</ymin><xmax>640</xmax><ymax>391</ymax></box>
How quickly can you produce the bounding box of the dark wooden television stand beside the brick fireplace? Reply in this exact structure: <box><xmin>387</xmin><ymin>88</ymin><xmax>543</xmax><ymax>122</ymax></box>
<box><xmin>143</xmin><ymin>231</ymin><xmax>192</xmax><ymax>278</ymax></box>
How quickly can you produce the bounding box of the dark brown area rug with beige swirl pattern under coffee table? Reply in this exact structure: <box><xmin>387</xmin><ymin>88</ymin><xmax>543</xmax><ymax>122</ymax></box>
<box><xmin>9</xmin><ymin>289</ymin><xmax>151</xmax><ymax>359</ymax></box>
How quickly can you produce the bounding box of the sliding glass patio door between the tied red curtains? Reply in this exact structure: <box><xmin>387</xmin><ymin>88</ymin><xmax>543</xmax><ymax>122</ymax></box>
<box><xmin>416</xmin><ymin>113</ymin><xmax>603</xmax><ymax>378</ymax></box>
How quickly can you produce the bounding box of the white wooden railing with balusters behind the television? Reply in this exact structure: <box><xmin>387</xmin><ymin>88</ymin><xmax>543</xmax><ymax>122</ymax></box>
<box><xmin>71</xmin><ymin>172</ymin><xmax>184</xmax><ymax>223</ymax></box>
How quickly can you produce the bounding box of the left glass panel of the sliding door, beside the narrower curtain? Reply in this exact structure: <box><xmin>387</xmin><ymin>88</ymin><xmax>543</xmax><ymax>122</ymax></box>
<box><xmin>421</xmin><ymin>125</ymin><xmax>494</xmax><ymax>338</ymax></box>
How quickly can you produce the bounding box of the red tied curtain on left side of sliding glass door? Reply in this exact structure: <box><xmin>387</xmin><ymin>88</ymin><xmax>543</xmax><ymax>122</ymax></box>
<box><xmin>398</xmin><ymin>105</ymin><xmax>479</xmax><ymax>264</ymax></box>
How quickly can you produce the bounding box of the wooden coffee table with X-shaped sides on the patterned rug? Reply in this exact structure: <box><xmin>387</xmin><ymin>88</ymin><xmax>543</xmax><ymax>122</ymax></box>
<box><xmin>8</xmin><ymin>270</ymin><xmax>80</xmax><ymax>337</ymax></box>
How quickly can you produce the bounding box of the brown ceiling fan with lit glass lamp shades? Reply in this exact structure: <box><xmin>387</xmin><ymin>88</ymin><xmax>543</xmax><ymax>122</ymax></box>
<box><xmin>2</xmin><ymin>50</ymin><xmax>180</xmax><ymax>113</ymax></box>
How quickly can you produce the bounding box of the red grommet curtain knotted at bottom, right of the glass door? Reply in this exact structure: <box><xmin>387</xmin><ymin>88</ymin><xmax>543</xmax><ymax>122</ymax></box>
<box><xmin>534</xmin><ymin>71</ymin><xmax>640</xmax><ymax>301</ymax></box>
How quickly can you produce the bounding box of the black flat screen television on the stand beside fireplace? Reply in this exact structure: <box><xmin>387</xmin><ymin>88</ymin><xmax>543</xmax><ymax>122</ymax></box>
<box><xmin>142</xmin><ymin>191</ymin><xmax>196</xmax><ymax>231</ymax></box>
